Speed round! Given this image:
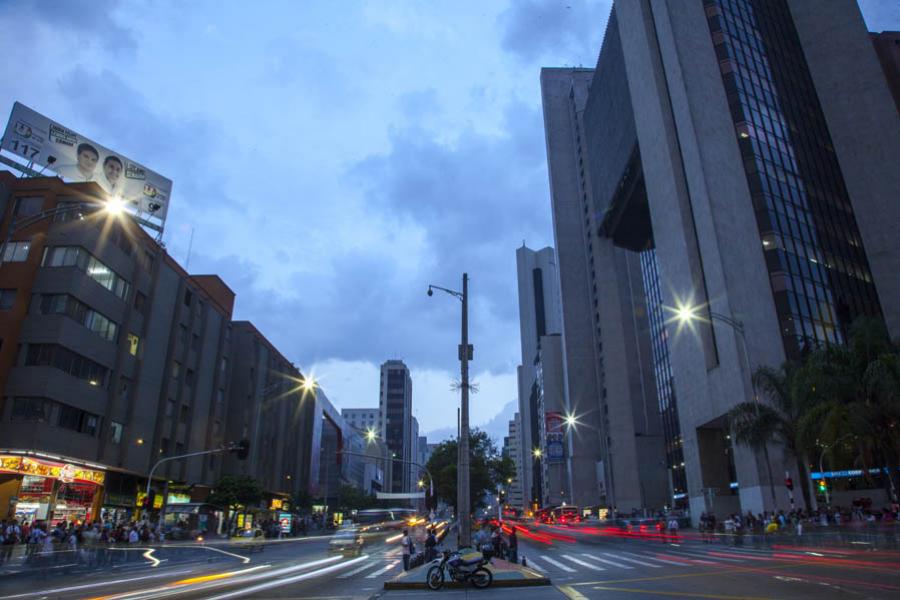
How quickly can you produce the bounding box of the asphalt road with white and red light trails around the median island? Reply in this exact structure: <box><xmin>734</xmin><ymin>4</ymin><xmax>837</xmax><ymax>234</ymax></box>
<box><xmin>0</xmin><ymin>525</ymin><xmax>900</xmax><ymax>600</ymax></box>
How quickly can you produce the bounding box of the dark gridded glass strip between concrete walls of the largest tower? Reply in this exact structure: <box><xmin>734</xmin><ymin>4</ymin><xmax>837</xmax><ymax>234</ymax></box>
<box><xmin>704</xmin><ymin>0</ymin><xmax>881</xmax><ymax>359</ymax></box>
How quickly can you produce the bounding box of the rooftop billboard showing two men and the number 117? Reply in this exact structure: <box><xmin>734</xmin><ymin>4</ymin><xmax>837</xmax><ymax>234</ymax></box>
<box><xmin>2</xmin><ymin>102</ymin><xmax>172</xmax><ymax>230</ymax></box>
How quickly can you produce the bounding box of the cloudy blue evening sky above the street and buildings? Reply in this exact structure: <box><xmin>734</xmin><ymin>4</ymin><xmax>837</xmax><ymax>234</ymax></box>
<box><xmin>0</xmin><ymin>0</ymin><xmax>900</xmax><ymax>441</ymax></box>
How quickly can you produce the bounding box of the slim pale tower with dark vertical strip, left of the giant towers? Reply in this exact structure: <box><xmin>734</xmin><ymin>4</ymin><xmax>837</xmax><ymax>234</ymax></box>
<box><xmin>516</xmin><ymin>244</ymin><xmax>562</xmax><ymax>505</ymax></box>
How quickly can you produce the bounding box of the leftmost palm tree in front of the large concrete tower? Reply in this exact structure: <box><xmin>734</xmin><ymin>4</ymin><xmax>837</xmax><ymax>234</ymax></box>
<box><xmin>727</xmin><ymin>362</ymin><xmax>812</xmax><ymax>510</ymax></box>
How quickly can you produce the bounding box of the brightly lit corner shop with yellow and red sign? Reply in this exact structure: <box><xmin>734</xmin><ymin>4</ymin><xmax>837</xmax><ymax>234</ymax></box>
<box><xmin>0</xmin><ymin>454</ymin><xmax>106</xmax><ymax>523</ymax></box>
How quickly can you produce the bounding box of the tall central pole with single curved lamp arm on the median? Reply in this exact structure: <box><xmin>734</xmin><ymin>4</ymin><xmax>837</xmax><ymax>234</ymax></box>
<box><xmin>428</xmin><ymin>273</ymin><xmax>473</xmax><ymax>547</ymax></box>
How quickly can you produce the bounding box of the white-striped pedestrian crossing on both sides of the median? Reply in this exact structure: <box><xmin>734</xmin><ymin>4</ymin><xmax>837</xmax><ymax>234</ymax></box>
<box><xmin>336</xmin><ymin>544</ymin><xmax>792</xmax><ymax>579</ymax></box>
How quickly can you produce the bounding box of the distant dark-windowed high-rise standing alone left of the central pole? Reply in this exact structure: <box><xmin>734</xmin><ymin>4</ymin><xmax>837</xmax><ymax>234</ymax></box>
<box><xmin>378</xmin><ymin>360</ymin><xmax>415</xmax><ymax>493</ymax></box>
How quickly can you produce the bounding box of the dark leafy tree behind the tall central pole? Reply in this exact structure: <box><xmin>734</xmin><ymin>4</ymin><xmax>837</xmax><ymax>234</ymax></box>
<box><xmin>427</xmin><ymin>429</ymin><xmax>515</xmax><ymax>508</ymax></box>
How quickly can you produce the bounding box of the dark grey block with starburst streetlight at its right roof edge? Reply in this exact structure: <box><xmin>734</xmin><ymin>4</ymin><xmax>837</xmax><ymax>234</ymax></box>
<box><xmin>224</xmin><ymin>321</ymin><xmax>315</xmax><ymax>499</ymax></box>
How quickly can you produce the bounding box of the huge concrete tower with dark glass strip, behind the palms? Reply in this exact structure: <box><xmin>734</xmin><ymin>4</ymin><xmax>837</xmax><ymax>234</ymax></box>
<box><xmin>556</xmin><ymin>0</ymin><xmax>900</xmax><ymax>518</ymax></box>
